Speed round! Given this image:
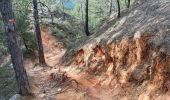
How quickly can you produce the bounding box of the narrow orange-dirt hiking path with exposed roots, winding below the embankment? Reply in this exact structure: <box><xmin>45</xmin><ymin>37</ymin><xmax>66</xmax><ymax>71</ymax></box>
<box><xmin>25</xmin><ymin>28</ymin><xmax>118</xmax><ymax>100</ymax></box>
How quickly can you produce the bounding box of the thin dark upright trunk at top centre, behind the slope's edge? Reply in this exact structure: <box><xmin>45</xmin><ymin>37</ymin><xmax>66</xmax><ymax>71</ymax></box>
<box><xmin>84</xmin><ymin>0</ymin><xmax>90</xmax><ymax>36</ymax></box>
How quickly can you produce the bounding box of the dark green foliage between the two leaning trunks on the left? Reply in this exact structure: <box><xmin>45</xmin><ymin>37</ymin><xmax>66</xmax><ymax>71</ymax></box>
<box><xmin>15</xmin><ymin>3</ymin><xmax>37</xmax><ymax>51</ymax></box>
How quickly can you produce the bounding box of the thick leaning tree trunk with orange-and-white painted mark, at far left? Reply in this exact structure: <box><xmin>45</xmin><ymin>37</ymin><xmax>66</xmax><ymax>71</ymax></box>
<box><xmin>0</xmin><ymin>0</ymin><xmax>30</xmax><ymax>95</ymax></box>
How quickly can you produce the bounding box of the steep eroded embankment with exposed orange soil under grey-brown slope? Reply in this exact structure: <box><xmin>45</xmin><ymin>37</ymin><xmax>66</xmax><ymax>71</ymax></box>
<box><xmin>63</xmin><ymin>0</ymin><xmax>170</xmax><ymax>100</ymax></box>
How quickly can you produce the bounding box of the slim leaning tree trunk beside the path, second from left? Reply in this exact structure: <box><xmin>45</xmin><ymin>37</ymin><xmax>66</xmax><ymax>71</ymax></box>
<box><xmin>33</xmin><ymin>0</ymin><xmax>46</xmax><ymax>64</ymax></box>
